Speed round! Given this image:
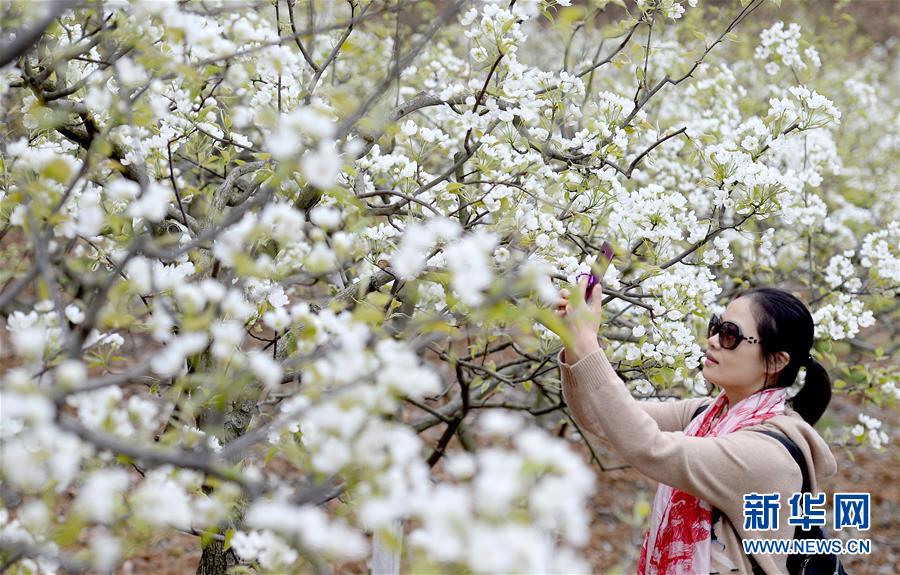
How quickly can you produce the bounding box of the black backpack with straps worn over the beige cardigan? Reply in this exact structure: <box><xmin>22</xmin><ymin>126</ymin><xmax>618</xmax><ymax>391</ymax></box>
<box><xmin>691</xmin><ymin>404</ymin><xmax>847</xmax><ymax>575</ymax></box>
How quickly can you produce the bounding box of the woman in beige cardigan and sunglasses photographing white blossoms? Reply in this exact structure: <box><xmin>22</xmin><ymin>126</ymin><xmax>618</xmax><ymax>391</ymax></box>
<box><xmin>557</xmin><ymin>279</ymin><xmax>837</xmax><ymax>574</ymax></box>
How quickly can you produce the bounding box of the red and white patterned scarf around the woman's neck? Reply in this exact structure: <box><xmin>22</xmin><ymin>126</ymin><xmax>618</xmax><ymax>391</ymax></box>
<box><xmin>638</xmin><ymin>388</ymin><xmax>787</xmax><ymax>575</ymax></box>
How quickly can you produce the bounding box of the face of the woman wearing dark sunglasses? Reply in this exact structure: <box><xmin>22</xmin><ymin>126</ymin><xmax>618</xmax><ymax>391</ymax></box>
<box><xmin>703</xmin><ymin>297</ymin><xmax>772</xmax><ymax>405</ymax></box>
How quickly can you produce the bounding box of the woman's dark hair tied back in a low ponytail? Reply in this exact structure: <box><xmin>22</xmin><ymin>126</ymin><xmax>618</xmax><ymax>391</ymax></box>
<box><xmin>736</xmin><ymin>287</ymin><xmax>831</xmax><ymax>425</ymax></box>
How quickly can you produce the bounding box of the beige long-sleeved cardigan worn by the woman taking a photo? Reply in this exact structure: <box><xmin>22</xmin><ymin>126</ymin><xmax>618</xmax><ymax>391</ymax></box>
<box><xmin>557</xmin><ymin>350</ymin><xmax>837</xmax><ymax>575</ymax></box>
